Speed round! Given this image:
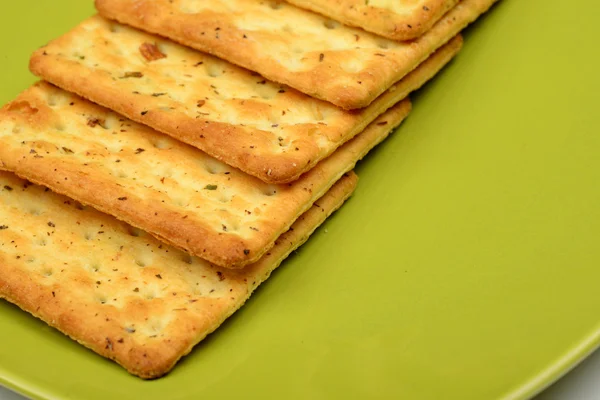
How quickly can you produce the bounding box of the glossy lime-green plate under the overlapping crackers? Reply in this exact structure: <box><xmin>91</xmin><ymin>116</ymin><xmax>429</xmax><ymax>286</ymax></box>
<box><xmin>0</xmin><ymin>0</ymin><xmax>600</xmax><ymax>400</ymax></box>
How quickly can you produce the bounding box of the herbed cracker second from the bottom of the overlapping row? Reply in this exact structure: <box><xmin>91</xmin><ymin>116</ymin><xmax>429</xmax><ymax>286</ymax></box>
<box><xmin>0</xmin><ymin>82</ymin><xmax>410</xmax><ymax>268</ymax></box>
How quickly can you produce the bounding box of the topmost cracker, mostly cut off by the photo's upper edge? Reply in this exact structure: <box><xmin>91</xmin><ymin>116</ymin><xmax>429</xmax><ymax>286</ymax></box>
<box><xmin>285</xmin><ymin>0</ymin><xmax>459</xmax><ymax>40</ymax></box>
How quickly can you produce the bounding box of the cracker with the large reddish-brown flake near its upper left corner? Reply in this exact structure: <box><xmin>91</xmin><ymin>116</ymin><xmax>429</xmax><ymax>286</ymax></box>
<box><xmin>31</xmin><ymin>17</ymin><xmax>462</xmax><ymax>183</ymax></box>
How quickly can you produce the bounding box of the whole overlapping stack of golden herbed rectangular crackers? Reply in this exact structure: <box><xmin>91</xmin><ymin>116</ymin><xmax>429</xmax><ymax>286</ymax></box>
<box><xmin>0</xmin><ymin>0</ymin><xmax>495</xmax><ymax>378</ymax></box>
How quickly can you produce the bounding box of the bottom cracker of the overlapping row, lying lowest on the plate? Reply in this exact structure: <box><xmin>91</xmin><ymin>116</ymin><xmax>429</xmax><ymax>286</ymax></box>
<box><xmin>0</xmin><ymin>172</ymin><xmax>357</xmax><ymax>378</ymax></box>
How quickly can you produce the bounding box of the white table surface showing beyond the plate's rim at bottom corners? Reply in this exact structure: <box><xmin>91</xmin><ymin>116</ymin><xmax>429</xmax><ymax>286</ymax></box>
<box><xmin>0</xmin><ymin>351</ymin><xmax>600</xmax><ymax>400</ymax></box>
